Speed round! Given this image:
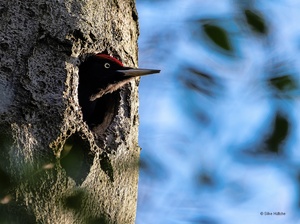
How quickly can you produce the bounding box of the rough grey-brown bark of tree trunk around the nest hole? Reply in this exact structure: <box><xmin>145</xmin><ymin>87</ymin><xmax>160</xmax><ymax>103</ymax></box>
<box><xmin>0</xmin><ymin>0</ymin><xmax>140</xmax><ymax>224</ymax></box>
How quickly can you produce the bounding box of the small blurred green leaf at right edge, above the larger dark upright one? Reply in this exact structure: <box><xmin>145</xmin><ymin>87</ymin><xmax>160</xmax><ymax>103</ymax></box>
<box><xmin>269</xmin><ymin>75</ymin><xmax>298</xmax><ymax>92</ymax></box>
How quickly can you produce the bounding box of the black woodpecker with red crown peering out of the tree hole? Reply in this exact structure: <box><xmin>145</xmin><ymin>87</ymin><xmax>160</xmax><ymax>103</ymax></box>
<box><xmin>78</xmin><ymin>54</ymin><xmax>160</xmax><ymax>126</ymax></box>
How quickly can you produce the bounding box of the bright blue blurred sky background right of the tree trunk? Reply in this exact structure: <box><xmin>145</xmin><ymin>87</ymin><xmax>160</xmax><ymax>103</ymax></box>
<box><xmin>136</xmin><ymin>0</ymin><xmax>300</xmax><ymax>224</ymax></box>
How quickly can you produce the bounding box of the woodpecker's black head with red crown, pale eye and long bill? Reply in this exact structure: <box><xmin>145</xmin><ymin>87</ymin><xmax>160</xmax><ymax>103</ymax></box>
<box><xmin>79</xmin><ymin>54</ymin><xmax>160</xmax><ymax>101</ymax></box>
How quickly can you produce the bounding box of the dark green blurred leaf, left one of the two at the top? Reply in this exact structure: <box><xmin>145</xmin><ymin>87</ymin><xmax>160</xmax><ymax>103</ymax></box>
<box><xmin>203</xmin><ymin>24</ymin><xmax>233</xmax><ymax>52</ymax></box>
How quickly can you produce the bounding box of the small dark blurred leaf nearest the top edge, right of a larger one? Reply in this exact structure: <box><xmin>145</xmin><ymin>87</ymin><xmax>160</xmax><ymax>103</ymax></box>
<box><xmin>244</xmin><ymin>9</ymin><xmax>267</xmax><ymax>34</ymax></box>
